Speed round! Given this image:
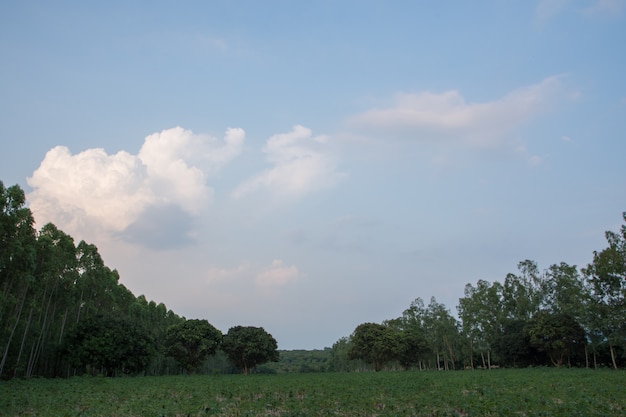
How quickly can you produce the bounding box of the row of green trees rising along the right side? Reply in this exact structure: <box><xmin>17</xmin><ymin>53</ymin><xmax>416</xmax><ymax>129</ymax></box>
<box><xmin>332</xmin><ymin>213</ymin><xmax>626</xmax><ymax>371</ymax></box>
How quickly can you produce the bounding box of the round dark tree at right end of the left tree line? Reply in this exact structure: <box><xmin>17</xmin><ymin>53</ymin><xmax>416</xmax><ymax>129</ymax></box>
<box><xmin>221</xmin><ymin>326</ymin><xmax>279</xmax><ymax>375</ymax></box>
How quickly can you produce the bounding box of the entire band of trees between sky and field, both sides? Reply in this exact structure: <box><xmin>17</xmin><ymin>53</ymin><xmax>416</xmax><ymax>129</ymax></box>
<box><xmin>0</xmin><ymin>181</ymin><xmax>626</xmax><ymax>379</ymax></box>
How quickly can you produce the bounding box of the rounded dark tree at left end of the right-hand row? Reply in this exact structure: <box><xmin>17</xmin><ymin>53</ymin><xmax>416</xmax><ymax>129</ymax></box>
<box><xmin>348</xmin><ymin>323</ymin><xmax>398</xmax><ymax>372</ymax></box>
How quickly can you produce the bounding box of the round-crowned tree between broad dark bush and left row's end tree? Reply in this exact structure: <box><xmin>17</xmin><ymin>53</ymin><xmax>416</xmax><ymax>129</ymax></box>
<box><xmin>165</xmin><ymin>319</ymin><xmax>222</xmax><ymax>374</ymax></box>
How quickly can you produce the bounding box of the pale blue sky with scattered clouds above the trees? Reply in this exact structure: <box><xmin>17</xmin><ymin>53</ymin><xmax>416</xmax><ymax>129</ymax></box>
<box><xmin>0</xmin><ymin>0</ymin><xmax>626</xmax><ymax>349</ymax></box>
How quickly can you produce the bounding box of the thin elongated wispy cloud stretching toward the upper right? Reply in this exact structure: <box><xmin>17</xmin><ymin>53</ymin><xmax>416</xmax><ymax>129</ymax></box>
<box><xmin>348</xmin><ymin>76</ymin><xmax>563</xmax><ymax>146</ymax></box>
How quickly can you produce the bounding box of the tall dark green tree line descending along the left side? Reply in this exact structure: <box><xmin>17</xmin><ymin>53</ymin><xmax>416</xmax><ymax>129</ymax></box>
<box><xmin>0</xmin><ymin>181</ymin><xmax>278</xmax><ymax>379</ymax></box>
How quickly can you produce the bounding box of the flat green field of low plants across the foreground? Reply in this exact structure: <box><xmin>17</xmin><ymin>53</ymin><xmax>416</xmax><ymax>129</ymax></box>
<box><xmin>0</xmin><ymin>369</ymin><xmax>626</xmax><ymax>417</ymax></box>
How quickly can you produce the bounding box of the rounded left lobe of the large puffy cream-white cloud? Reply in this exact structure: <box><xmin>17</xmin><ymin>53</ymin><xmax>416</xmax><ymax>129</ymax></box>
<box><xmin>28</xmin><ymin>146</ymin><xmax>155</xmax><ymax>231</ymax></box>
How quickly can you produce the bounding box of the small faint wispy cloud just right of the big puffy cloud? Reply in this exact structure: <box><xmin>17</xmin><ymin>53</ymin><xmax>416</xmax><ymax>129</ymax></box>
<box><xmin>233</xmin><ymin>126</ymin><xmax>341</xmax><ymax>198</ymax></box>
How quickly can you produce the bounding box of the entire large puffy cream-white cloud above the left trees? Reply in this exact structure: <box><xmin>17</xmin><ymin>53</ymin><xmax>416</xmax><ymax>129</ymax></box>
<box><xmin>28</xmin><ymin>127</ymin><xmax>245</xmax><ymax>244</ymax></box>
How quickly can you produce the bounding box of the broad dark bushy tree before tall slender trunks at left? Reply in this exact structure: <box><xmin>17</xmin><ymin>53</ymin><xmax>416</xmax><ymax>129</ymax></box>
<box><xmin>63</xmin><ymin>315</ymin><xmax>154</xmax><ymax>376</ymax></box>
